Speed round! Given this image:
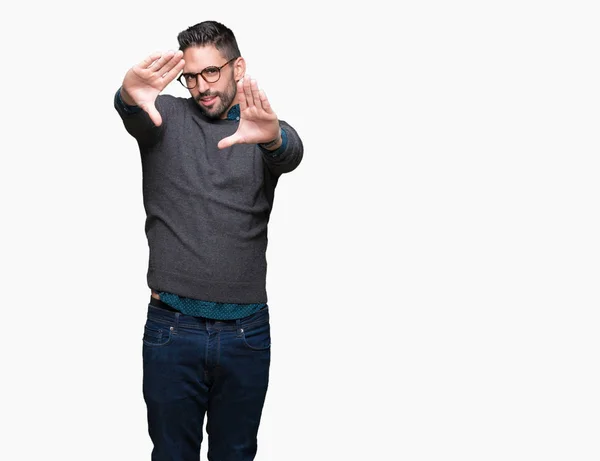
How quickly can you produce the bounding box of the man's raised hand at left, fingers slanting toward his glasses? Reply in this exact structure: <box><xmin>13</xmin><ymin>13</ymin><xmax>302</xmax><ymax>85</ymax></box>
<box><xmin>121</xmin><ymin>51</ymin><xmax>185</xmax><ymax>126</ymax></box>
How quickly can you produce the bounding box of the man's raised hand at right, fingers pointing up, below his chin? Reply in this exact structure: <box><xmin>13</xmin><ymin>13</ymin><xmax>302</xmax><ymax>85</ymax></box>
<box><xmin>218</xmin><ymin>75</ymin><xmax>279</xmax><ymax>149</ymax></box>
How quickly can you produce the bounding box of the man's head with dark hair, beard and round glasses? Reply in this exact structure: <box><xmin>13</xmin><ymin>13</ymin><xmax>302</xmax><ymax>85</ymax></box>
<box><xmin>177</xmin><ymin>21</ymin><xmax>246</xmax><ymax>119</ymax></box>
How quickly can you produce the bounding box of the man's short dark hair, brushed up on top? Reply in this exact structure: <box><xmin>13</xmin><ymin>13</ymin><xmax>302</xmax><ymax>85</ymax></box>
<box><xmin>177</xmin><ymin>21</ymin><xmax>242</xmax><ymax>60</ymax></box>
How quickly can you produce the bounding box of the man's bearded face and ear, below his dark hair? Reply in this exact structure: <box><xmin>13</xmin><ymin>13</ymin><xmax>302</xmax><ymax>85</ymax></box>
<box><xmin>183</xmin><ymin>46</ymin><xmax>245</xmax><ymax>119</ymax></box>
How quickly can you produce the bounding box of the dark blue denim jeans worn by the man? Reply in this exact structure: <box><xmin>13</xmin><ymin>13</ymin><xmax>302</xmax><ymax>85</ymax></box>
<box><xmin>142</xmin><ymin>298</ymin><xmax>271</xmax><ymax>461</ymax></box>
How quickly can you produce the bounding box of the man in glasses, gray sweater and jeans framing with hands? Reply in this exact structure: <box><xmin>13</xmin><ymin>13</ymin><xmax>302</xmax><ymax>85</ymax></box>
<box><xmin>114</xmin><ymin>21</ymin><xmax>303</xmax><ymax>461</ymax></box>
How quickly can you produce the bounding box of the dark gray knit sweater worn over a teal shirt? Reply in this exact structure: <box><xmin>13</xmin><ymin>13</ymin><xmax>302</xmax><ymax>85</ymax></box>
<box><xmin>115</xmin><ymin>95</ymin><xmax>303</xmax><ymax>303</ymax></box>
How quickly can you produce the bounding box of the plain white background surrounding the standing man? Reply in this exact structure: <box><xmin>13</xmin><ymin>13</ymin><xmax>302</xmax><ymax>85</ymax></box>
<box><xmin>0</xmin><ymin>0</ymin><xmax>600</xmax><ymax>461</ymax></box>
